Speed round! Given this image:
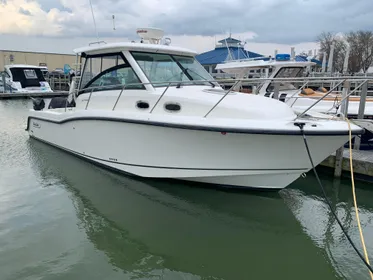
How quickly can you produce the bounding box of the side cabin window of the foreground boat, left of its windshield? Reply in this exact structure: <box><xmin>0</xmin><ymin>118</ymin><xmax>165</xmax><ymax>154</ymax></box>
<box><xmin>81</xmin><ymin>54</ymin><xmax>145</xmax><ymax>92</ymax></box>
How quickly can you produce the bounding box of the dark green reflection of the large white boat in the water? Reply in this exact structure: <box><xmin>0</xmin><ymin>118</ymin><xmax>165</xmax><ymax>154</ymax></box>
<box><xmin>28</xmin><ymin>139</ymin><xmax>338</xmax><ymax>279</ymax></box>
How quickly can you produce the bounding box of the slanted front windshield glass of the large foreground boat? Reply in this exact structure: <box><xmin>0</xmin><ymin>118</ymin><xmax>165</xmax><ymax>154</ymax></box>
<box><xmin>131</xmin><ymin>52</ymin><xmax>215</xmax><ymax>87</ymax></box>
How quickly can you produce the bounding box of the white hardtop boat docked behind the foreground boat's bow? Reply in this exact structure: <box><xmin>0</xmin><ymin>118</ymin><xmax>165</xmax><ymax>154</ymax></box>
<box><xmin>216</xmin><ymin>54</ymin><xmax>373</xmax><ymax>118</ymax></box>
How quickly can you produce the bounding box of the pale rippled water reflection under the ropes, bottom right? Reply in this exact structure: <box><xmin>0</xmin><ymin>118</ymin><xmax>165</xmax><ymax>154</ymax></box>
<box><xmin>281</xmin><ymin>174</ymin><xmax>373</xmax><ymax>279</ymax></box>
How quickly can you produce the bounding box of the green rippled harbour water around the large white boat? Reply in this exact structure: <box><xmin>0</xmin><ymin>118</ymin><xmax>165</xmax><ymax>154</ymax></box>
<box><xmin>0</xmin><ymin>100</ymin><xmax>373</xmax><ymax>280</ymax></box>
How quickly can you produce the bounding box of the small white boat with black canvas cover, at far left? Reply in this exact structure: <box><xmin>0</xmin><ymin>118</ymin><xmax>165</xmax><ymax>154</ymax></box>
<box><xmin>0</xmin><ymin>64</ymin><xmax>53</xmax><ymax>93</ymax></box>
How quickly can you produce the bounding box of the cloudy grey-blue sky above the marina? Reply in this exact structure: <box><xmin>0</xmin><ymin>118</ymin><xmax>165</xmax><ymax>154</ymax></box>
<box><xmin>0</xmin><ymin>0</ymin><xmax>373</xmax><ymax>55</ymax></box>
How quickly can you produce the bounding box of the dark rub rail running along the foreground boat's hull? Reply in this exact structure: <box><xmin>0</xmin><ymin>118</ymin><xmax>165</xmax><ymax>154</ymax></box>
<box><xmin>26</xmin><ymin>116</ymin><xmax>364</xmax><ymax>136</ymax></box>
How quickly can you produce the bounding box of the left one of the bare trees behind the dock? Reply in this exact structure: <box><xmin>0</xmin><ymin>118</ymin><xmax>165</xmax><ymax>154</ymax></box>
<box><xmin>317</xmin><ymin>32</ymin><xmax>347</xmax><ymax>72</ymax></box>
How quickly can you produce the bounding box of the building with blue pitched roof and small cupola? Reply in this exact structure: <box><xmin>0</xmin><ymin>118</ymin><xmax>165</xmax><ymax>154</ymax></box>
<box><xmin>196</xmin><ymin>36</ymin><xmax>263</xmax><ymax>78</ymax></box>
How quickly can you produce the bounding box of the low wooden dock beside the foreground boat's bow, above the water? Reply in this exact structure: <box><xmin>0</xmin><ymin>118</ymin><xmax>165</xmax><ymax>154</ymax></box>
<box><xmin>319</xmin><ymin>149</ymin><xmax>373</xmax><ymax>182</ymax></box>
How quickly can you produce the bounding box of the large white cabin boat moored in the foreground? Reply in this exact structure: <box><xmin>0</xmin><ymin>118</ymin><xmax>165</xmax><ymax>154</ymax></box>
<box><xmin>27</xmin><ymin>29</ymin><xmax>363</xmax><ymax>189</ymax></box>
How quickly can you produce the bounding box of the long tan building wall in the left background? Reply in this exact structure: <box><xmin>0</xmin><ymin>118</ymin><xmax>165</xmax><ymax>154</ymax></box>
<box><xmin>0</xmin><ymin>50</ymin><xmax>76</xmax><ymax>71</ymax></box>
